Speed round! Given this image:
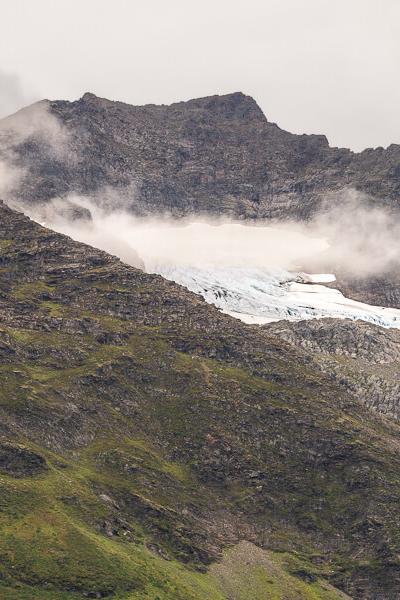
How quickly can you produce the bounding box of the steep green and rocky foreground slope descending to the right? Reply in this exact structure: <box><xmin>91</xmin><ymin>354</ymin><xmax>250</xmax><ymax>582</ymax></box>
<box><xmin>0</xmin><ymin>200</ymin><xmax>400</xmax><ymax>600</ymax></box>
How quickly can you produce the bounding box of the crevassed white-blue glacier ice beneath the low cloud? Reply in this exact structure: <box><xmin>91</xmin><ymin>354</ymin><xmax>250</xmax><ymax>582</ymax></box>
<box><xmin>151</xmin><ymin>263</ymin><xmax>400</xmax><ymax>329</ymax></box>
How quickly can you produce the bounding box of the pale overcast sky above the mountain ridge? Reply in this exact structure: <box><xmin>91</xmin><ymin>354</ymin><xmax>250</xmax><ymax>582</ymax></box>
<box><xmin>0</xmin><ymin>0</ymin><xmax>400</xmax><ymax>150</ymax></box>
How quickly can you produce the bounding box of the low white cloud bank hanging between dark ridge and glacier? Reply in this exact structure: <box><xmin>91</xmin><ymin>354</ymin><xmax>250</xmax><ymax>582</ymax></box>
<box><xmin>9</xmin><ymin>190</ymin><xmax>400</xmax><ymax>276</ymax></box>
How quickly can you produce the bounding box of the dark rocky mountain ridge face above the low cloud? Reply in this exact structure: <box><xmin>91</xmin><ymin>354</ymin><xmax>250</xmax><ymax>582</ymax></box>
<box><xmin>0</xmin><ymin>93</ymin><xmax>400</xmax><ymax>219</ymax></box>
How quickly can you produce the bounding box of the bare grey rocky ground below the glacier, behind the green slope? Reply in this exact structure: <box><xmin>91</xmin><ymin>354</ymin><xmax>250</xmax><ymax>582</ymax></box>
<box><xmin>266</xmin><ymin>319</ymin><xmax>400</xmax><ymax>420</ymax></box>
